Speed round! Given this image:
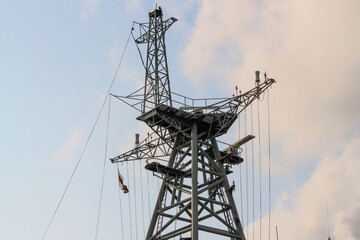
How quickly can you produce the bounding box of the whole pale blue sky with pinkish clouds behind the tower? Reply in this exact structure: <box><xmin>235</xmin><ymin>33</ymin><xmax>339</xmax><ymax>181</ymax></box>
<box><xmin>0</xmin><ymin>0</ymin><xmax>360</xmax><ymax>240</ymax></box>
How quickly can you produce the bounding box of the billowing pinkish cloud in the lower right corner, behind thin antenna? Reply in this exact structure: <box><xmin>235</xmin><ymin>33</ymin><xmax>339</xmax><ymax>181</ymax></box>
<box><xmin>245</xmin><ymin>138</ymin><xmax>360</xmax><ymax>240</ymax></box>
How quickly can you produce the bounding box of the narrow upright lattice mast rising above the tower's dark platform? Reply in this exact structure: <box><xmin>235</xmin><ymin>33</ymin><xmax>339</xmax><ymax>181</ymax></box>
<box><xmin>136</xmin><ymin>8</ymin><xmax>177</xmax><ymax>112</ymax></box>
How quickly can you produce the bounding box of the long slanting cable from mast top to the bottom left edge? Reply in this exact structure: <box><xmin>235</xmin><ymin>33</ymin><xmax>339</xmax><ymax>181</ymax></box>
<box><xmin>41</xmin><ymin>25</ymin><xmax>131</xmax><ymax>240</ymax></box>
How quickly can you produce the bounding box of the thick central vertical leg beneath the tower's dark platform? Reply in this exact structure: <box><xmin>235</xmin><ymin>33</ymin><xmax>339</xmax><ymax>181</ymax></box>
<box><xmin>191</xmin><ymin>123</ymin><xmax>199</xmax><ymax>240</ymax></box>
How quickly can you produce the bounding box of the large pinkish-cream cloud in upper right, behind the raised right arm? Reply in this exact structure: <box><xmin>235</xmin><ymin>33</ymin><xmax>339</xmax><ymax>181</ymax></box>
<box><xmin>182</xmin><ymin>0</ymin><xmax>360</xmax><ymax>164</ymax></box>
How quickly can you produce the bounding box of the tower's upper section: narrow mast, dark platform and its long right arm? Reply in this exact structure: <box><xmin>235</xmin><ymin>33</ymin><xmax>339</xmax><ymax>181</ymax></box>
<box><xmin>116</xmin><ymin>7</ymin><xmax>275</xmax><ymax>142</ymax></box>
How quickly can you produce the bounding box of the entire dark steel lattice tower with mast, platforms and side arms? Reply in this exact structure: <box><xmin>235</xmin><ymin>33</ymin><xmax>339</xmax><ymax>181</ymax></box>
<box><xmin>111</xmin><ymin>8</ymin><xmax>275</xmax><ymax>240</ymax></box>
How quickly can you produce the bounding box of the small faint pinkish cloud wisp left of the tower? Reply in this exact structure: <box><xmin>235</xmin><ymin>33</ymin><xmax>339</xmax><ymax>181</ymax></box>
<box><xmin>53</xmin><ymin>128</ymin><xmax>84</xmax><ymax>160</ymax></box>
